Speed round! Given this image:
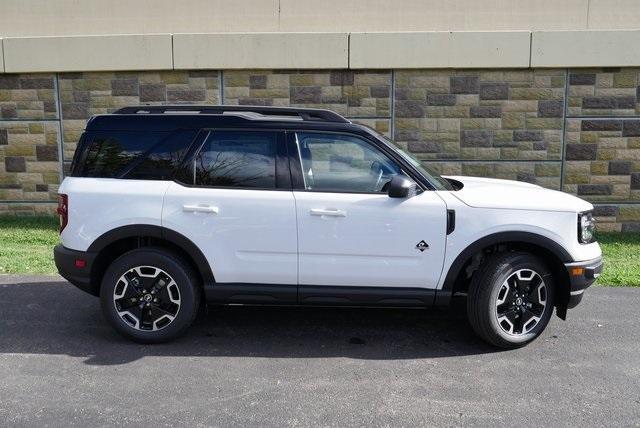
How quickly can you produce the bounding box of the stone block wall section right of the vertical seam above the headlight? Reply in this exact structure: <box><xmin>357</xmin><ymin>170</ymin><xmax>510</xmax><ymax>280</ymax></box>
<box><xmin>563</xmin><ymin>68</ymin><xmax>640</xmax><ymax>232</ymax></box>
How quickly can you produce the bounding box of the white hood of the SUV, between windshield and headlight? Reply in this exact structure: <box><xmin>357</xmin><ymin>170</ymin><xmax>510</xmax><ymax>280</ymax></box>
<box><xmin>445</xmin><ymin>176</ymin><xmax>593</xmax><ymax>212</ymax></box>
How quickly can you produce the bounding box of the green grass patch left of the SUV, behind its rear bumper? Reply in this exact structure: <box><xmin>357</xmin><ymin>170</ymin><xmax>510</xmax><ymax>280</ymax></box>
<box><xmin>0</xmin><ymin>216</ymin><xmax>59</xmax><ymax>274</ymax></box>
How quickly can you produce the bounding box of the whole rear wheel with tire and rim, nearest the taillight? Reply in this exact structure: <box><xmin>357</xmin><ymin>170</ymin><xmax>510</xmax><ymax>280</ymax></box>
<box><xmin>100</xmin><ymin>247</ymin><xmax>201</xmax><ymax>343</ymax></box>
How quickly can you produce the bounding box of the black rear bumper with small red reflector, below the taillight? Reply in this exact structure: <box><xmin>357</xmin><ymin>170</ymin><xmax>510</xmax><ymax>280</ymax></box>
<box><xmin>53</xmin><ymin>244</ymin><xmax>99</xmax><ymax>296</ymax></box>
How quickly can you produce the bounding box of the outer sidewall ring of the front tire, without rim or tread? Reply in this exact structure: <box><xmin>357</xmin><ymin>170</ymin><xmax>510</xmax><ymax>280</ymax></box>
<box><xmin>486</xmin><ymin>254</ymin><xmax>555</xmax><ymax>345</ymax></box>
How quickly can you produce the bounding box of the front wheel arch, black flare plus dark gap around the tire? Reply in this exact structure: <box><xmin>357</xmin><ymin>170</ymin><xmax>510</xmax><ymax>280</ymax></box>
<box><xmin>439</xmin><ymin>231</ymin><xmax>573</xmax><ymax>319</ymax></box>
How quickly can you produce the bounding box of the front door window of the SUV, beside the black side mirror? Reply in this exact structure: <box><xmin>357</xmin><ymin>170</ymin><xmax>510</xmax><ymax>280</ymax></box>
<box><xmin>296</xmin><ymin>132</ymin><xmax>402</xmax><ymax>193</ymax></box>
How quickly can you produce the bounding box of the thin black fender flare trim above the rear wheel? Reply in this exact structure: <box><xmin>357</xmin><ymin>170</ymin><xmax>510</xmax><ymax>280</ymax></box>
<box><xmin>87</xmin><ymin>224</ymin><xmax>215</xmax><ymax>284</ymax></box>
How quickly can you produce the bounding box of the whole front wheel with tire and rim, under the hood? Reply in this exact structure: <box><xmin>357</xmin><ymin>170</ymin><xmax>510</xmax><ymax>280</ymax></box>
<box><xmin>467</xmin><ymin>252</ymin><xmax>555</xmax><ymax>349</ymax></box>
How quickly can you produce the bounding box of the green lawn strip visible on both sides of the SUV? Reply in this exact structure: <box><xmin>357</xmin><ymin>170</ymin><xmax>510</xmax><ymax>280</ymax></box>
<box><xmin>0</xmin><ymin>217</ymin><xmax>640</xmax><ymax>287</ymax></box>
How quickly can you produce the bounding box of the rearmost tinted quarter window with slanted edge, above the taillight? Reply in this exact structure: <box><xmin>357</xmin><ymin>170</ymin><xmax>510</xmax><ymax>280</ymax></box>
<box><xmin>74</xmin><ymin>131</ymin><xmax>167</xmax><ymax>178</ymax></box>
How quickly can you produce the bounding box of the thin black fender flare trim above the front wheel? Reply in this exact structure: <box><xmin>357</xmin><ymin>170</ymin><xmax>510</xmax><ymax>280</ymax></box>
<box><xmin>440</xmin><ymin>232</ymin><xmax>573</xmax><ymax>295</ymax></box>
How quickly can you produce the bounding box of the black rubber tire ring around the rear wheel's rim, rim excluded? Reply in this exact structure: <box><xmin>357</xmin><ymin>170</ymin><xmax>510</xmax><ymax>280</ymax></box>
<box><xmin>100</xmin><ymin>249</ymin><xmax>199</xmax><ymax>343</ymax></box>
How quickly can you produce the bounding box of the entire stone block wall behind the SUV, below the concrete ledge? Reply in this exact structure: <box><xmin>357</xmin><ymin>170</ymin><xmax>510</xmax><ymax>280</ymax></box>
<box><xmin>0</xmin><ymin>68</ymin><xmax>640</xmax><ymax>231</ymax></box>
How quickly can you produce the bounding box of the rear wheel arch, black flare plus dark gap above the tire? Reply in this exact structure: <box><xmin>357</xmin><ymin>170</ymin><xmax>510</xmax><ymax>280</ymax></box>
<box><xmin>87</xmin><ymin>224</ymin><xmax>215</xmax><ymax>290</ymax></box>
